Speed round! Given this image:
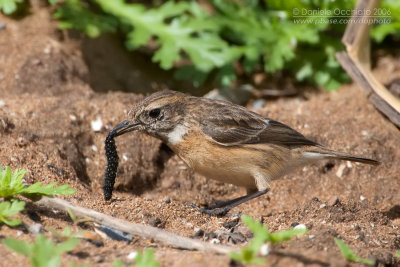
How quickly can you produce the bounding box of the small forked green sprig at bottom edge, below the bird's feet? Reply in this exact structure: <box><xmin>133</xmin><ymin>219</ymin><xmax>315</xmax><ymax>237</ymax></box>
<box><xmin>231</xmin><ymin>215</ymin><xmax>307</xmax><ymax>264</ymax></box>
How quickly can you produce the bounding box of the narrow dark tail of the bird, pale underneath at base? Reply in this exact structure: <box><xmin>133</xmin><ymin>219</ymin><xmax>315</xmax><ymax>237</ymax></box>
<box><xmin>303</xmin><ymin>147</ymin><xmax>380</xmax><ymax>165</ymax></box>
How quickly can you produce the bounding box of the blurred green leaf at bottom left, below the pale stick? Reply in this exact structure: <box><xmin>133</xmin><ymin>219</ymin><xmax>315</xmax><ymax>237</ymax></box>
<box><xmin>3</xmin><ymin>234</ymin><xmax>79</xmax><ymax>267</ymax></box>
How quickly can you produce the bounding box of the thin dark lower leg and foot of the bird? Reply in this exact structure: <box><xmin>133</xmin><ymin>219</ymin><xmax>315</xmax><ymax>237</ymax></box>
<box><xmin>188</xmin><ymin>188</ymin><xmax>269</xmax><ymax>215</ymax></box>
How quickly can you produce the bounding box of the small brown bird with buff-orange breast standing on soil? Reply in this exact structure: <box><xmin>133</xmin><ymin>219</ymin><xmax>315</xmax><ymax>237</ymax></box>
<box><xmin>111</xmin><ymin>91</ymin><xmax>378</xmax><ymax>215</ymax></box>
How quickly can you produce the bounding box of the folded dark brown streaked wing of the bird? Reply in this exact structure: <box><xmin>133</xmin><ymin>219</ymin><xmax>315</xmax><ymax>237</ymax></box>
<box><xmin>201</xmin><ymin>108</ymin><xmax>318</xmax><ymax>148</ymax></box>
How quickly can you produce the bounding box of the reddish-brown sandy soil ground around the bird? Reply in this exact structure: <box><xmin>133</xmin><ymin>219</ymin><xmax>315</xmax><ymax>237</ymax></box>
<box><xmin>0</xmin><ymin>4</ymin><xmax>400</xmax><ymax>267</ymax></box>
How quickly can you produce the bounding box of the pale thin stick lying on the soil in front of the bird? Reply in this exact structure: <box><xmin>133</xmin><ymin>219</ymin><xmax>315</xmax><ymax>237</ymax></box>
<box><xmin>35</xmin><ymin>197</ymin><xmax>234</xmax><ymax>254</ymax></box>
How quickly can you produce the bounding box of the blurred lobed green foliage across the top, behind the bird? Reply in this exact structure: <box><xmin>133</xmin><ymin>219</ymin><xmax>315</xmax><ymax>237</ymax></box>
<box><xmin>0</xmin><ymin>0</ymin><xmax>400</xmax><ymax>90</ymax></box>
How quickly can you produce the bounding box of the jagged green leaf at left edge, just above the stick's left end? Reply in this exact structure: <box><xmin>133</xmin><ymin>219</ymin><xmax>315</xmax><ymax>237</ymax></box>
<box><xmin>0</xmin><ymin>166</ymin><xmax>76</xmax><ymax>199</ymax></box>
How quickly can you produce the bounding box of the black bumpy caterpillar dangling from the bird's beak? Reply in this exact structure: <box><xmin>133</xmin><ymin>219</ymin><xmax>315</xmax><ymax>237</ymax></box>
<box><xmin>103</xmin><ymin>130</ymin><xmax>119</xmax><ymax>200</ymax></box>
